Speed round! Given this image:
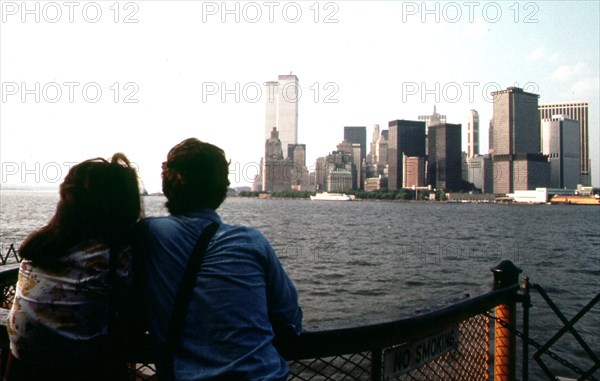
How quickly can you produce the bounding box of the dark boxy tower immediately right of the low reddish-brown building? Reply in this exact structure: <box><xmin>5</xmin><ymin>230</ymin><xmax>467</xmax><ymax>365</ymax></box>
<box><xmin>427</xmin><ymin>123</ymin><xmax>462</xmax><ymax>191</ymax></box>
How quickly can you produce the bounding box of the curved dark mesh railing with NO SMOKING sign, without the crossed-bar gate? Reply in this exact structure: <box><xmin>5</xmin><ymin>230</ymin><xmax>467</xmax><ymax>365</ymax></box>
<box><xmin>0</xmin><ymin>262</ymin><xmax>519</xmax><ymax>381</ymax></box>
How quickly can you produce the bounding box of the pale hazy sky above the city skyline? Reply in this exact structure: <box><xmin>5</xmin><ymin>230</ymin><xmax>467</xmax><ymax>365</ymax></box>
<box><xmin>0</xmin><ymin>0</ymin><xmax>600</xmax><ymax>192</ymax></box>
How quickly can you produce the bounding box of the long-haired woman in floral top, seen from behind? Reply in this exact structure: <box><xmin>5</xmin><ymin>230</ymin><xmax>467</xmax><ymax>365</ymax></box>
<box><xmin>5</xmin><ymin>153</ymin><xmax>141</xmax><ymax>381</ymax></box>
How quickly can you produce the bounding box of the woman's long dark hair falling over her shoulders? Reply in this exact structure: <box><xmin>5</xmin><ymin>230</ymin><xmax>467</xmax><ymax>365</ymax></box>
<box><xmin>19</xmin><ymin>153</ymin><xmax>142</xmax><ymax>265</ymax></box>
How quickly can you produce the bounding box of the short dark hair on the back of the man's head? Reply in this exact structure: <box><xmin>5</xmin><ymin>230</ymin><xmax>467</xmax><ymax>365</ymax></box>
<box><xmin>162</xmin><ymin>138</ymin><xmax>229</xmax><ymax>215</ymax></box>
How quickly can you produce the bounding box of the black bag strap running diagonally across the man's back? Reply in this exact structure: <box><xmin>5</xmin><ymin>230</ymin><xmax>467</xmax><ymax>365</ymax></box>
<box><xmin>165</xmin><ymin>222</ymin><xmax>219</xmax><ymax>380</ymax></box>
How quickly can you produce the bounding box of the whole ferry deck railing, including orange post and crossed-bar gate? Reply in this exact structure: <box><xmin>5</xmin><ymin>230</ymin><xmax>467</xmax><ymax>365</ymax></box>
<box><xmin>0</xmin><ymin>246</ymin><xmax>600</xmax><ymax>381</ymax></box>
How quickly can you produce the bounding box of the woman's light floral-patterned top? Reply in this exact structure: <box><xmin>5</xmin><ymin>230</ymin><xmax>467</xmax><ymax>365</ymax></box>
<box><xmin>7</xmin><ymin>241</ymin><xmax>131</xmax><ymax>363</ymax></box>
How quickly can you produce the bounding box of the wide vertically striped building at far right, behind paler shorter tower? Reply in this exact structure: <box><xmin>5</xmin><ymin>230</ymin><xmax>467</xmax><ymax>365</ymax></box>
<box><xmin>539</xmin><ymin>102</ymin><xmax>592</xmax><ymax>186</ymax></box>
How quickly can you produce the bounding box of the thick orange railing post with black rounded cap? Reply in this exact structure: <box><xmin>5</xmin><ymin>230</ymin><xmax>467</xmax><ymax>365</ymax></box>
<box><xmin>491</xmin><ymin>260</ymin><xmax>521</xmax><ymax>381</ymax></box>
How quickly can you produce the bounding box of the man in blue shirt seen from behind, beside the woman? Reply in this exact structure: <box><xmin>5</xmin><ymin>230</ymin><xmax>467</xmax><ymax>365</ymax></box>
<box><xmin>138</xmin><ymin>138</ymin><xmax>302</xmax><ymax>381</ymax></box>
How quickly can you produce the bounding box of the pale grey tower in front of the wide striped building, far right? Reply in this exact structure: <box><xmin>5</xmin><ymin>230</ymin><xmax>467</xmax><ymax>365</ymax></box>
<box><xmin>542</xmin><ymin>115</ymin><xmax>581</xmax><ymax>189</ymax></box>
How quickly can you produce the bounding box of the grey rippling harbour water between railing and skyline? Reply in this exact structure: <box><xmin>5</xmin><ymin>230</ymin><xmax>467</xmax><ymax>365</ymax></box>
<box><xmin>0</xmin><ymin>191</ymin><xmax>600</xmax><ymax>374</ymax></box>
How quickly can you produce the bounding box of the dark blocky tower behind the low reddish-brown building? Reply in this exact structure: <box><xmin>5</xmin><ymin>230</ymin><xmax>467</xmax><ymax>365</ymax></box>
<box><xmin>387</xmin><ymin>120</ymin><xmax>425</xmax><ymax>190</ymax></box>
